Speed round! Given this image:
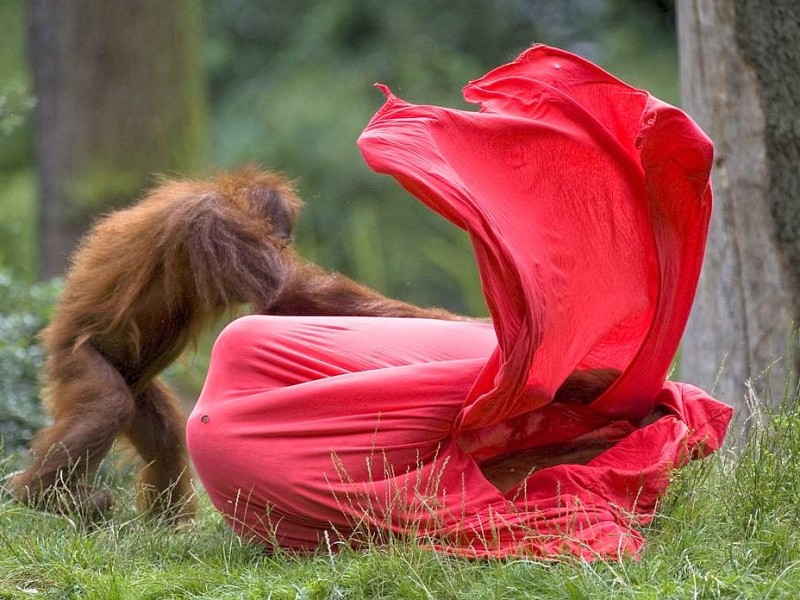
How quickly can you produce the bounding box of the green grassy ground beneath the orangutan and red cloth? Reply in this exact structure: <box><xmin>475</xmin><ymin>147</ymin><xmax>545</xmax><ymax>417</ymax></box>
<box><xmin>0</xmin><ymin>394</ymin><xmax>800</xmax><ymax>600</ymax></box>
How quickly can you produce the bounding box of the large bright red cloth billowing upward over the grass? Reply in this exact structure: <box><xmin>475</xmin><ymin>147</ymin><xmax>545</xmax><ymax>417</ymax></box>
<box><xmin>188</xmin><ymin>46</ymin><xmax>731</xmax><ymax>558</ymax></box>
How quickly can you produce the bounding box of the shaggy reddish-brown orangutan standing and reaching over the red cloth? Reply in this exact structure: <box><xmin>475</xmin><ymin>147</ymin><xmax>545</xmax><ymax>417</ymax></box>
<box><xmin>9</xmin><ymin>168</ymin><xmax>460</xmax><ymax>519</ymax></box>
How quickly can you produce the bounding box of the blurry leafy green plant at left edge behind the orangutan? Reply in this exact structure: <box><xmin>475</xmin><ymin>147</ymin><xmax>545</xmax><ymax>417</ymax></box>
<box><xmin>0</xmin><ymin>270</ymin><xmax>60</xmax><ymax>460</ymax></box>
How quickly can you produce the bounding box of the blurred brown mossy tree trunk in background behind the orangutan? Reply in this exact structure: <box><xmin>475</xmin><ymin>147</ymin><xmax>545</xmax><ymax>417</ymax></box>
<box><xmin>29</xmin><ymin>0</ymin><xmax>205</xmax><ymax>277</ymax></box>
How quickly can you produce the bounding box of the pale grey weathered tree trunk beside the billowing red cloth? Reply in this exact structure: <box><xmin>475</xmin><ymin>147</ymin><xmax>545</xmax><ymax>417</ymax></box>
<box><xmin>677</xmin><ymin>0</ymin><xmax>800</xmax><ymax>417</ymax></box>
